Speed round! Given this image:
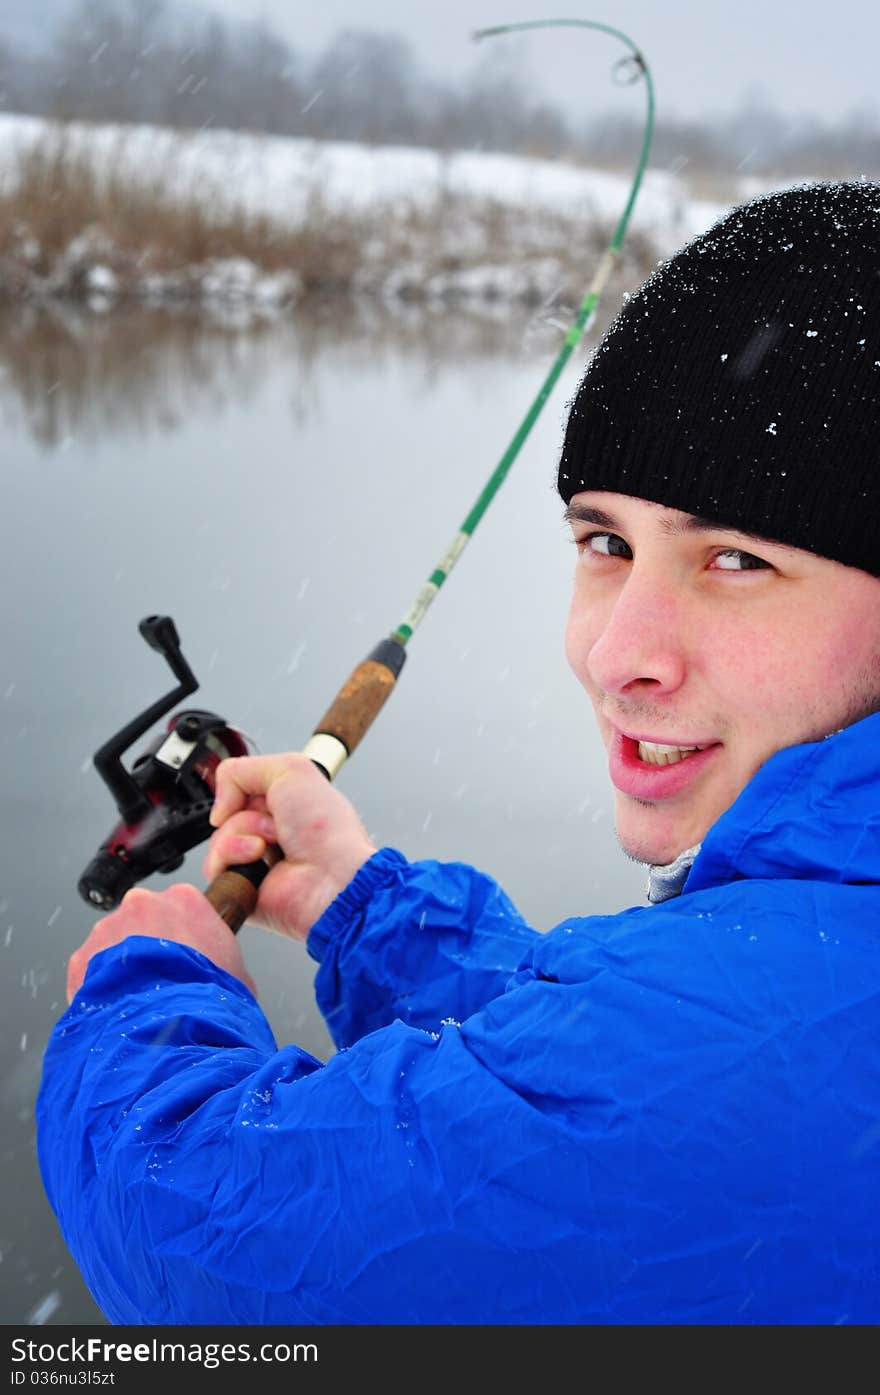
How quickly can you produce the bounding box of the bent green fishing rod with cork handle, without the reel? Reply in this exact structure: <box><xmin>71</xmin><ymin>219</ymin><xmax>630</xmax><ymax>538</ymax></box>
<box><xmin>205</xmin><ymin>20</ymin><xmax>654</xmax><ymax>930</ymax></box>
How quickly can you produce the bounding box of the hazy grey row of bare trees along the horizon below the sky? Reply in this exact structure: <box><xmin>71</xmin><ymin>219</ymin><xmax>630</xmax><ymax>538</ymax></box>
<box><xmin>0</xmin><ymin>0</ymin><xmax>880</xmax><ymax>181</ymax></box>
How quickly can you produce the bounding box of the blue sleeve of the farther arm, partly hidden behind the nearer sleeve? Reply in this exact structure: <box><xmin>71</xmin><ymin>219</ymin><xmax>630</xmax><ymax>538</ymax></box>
<box><xmin>308</xmin><ymin>848</ymin><xmax>540</xmax><ymax>1046</ymax></box>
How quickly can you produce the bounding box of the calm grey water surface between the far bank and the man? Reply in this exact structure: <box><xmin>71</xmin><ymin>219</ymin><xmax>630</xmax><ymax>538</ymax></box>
<box><xmin>0</xmin><ymin>299</ymin><xmax>643</xmax><ymax>1324</ymax></box>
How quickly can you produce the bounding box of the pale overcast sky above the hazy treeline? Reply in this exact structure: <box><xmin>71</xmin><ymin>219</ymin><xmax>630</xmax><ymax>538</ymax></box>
<box><xmin>201</xmin><ymin>0</ymin><xmax>880</xmax><ymax>121</ymax></box>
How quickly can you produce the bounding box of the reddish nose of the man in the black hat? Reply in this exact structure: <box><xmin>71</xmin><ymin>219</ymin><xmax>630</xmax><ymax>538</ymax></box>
<box><xmin>576</xmin><ymin>562</ymin><xmax>693</xmax><ymax>698</ymax></box>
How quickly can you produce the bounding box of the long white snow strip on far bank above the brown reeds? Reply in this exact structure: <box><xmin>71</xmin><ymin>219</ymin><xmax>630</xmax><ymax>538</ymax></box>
<box><xmin>0</xmin><ymin>114</ymin><xmax>722</xmax><ymax>246</ymax></box>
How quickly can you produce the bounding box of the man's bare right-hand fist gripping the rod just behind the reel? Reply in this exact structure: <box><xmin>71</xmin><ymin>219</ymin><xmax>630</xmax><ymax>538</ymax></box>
<box><xmin>205</xmin><ymin>752</ymin><xmax>377</xmax><ymax>940</ymax></box>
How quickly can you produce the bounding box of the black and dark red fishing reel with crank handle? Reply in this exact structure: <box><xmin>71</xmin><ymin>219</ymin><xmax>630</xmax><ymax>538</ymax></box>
<box><xmin>78</xmin><ymin>615</ymin><xmax>248</xmax><ymax>911</ymax></box>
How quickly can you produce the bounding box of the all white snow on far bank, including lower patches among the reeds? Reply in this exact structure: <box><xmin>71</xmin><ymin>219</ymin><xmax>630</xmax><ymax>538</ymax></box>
<box><xmin>0</xmin><ymin>114</ymin><xmax>775</xmax><ymax>306</ymax></box>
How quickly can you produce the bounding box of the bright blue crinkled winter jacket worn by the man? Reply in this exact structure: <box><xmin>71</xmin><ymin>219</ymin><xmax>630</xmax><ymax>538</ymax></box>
<box><xmin>38</xmin><ymin>714</ymin><xmax>880</xmax><ymax>1324</ymax></box>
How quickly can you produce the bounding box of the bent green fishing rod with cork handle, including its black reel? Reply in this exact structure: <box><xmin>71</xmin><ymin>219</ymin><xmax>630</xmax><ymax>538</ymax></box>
<box><xmin>79</xmin><ymin>20</ymin><xmax>654</xmax><ymax>932</ymax></box>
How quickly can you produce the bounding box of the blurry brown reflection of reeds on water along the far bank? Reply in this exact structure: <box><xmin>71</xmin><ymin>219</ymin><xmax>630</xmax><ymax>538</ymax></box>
<box><xmin>0</xmin><ymin>300</ymin><xmax>619</xmax><ymax>448</ymax></box>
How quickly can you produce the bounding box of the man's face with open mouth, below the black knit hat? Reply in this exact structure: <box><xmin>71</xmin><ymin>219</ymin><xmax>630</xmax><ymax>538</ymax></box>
<box><xmin>565</xmin><ymin>491</ymin><xmax>880</xmax><ymax>864</ymax></box>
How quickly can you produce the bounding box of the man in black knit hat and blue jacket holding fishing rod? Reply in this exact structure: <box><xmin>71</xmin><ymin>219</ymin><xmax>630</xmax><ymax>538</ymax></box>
<box><xmin>38</xmin><ymin>183</ymin><xmax>880</xmax><ymax>1324</ymax></box>
